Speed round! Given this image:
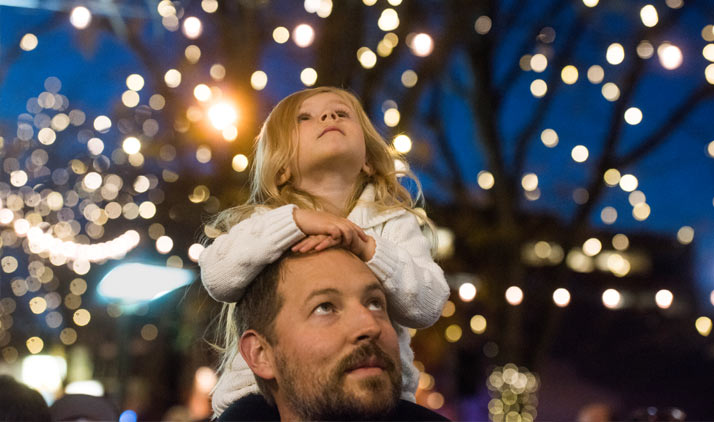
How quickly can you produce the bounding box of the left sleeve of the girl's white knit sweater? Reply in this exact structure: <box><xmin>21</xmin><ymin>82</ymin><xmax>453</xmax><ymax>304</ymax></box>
<box><xmin>198</xmin><ymin>205</ymin><xmax>305</xmax><ymax>302</ymax></box>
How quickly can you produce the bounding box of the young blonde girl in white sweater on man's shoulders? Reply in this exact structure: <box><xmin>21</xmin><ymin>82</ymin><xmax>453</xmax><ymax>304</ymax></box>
<box><xmin>199</xmin><ymin>87</ymin><xmax>449</xmax><ymax>414</ymax></box>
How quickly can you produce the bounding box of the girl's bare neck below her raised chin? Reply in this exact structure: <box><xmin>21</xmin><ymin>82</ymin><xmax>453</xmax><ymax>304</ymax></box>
<box><xmin>296</xmin><ymin>172</ymin><xmax>357</xmax><ymax>216</ymax></box>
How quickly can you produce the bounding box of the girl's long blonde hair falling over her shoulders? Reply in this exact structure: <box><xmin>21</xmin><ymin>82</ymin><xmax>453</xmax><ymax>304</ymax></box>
<box><xmin>208</xmin><ymin>87</ymin><xmax>425</xmax><ymax>233</ymax></box>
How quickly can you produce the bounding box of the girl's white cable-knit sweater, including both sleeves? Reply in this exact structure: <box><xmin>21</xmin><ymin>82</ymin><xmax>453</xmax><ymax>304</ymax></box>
<box><xmin>199</xmin><ymin>185</ymin><xmax>449</xmax><ymax>414</ymax></box>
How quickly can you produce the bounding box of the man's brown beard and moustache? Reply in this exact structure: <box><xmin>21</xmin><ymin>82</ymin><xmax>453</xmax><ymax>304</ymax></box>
<box><xmin>276</xmin><ymin>343</ymin><xmax>402</xmax><ymax>420</ymax></box>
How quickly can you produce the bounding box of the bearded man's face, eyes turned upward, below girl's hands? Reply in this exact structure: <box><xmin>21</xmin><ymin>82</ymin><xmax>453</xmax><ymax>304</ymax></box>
<box><xmin>273</xmin><ymin>249</ymin><xmax>401</xmax><ymax>420</ymax></box>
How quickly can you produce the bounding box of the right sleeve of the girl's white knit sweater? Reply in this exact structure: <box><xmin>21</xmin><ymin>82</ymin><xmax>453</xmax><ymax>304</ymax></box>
<box><xmin>367</xmin><ymin>213</ymin><xmax>449</xmax><ymax>328</ymax></box>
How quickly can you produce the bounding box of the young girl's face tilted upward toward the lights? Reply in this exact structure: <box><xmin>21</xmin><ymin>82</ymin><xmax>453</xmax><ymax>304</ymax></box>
<box><xmin>296</xmin><ymin>92</ymin><xmax>366</xmax><ymax>182</ymax></box>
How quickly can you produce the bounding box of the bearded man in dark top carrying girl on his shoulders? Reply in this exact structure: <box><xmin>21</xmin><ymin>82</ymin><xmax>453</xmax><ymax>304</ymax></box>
<box><xmin>219</xmin><ymin>248</ymin><xmax>445</xmax><ymax>420</ymax></box>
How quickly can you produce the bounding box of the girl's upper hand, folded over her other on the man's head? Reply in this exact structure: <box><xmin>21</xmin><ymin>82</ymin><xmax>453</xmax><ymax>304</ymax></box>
<box><xmin>293</xmin><ymin>208</ymin><xmax>367</xmax><ymax>245</ymax></box>
